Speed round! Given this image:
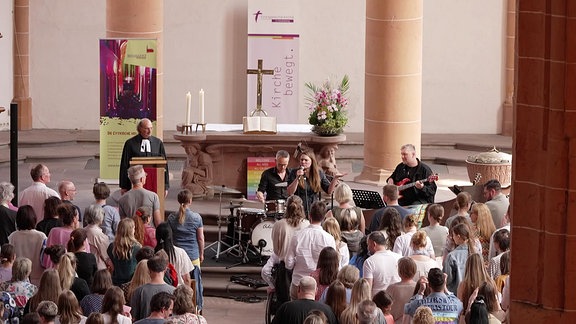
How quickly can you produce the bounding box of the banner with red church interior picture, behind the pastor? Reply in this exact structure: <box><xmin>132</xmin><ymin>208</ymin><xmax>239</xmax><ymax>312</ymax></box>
<box><xmin>100</xmin><ymin>39</ymin><xmax>156</xmax><ymax>180</ymax></box>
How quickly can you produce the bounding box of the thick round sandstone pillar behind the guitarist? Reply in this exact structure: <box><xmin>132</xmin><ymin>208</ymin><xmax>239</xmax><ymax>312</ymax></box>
<box><xmin>355</xmin><ymin>0</ymin><xmax>423</xmax><ymax>185</ymax></box>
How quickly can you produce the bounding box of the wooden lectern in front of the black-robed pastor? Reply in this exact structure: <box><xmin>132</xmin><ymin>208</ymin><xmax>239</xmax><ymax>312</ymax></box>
<box><xmin>130</xmin><ymin>156</ymin><xmax>168</xmax><ymax>220</ymax></box>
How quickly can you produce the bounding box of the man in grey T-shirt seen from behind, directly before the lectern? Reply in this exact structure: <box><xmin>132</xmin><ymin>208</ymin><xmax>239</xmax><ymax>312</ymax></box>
<box><xmin>118</xmin><ymin>165</ymin><xmax>164</xmax><ymax>226</ymax></box>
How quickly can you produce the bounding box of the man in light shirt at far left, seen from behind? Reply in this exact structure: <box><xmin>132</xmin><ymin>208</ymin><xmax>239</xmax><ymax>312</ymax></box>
<box><xmin>18</xmin><ymin>164</ymin><xmax>60</xmax><ymax>220</ymax></box>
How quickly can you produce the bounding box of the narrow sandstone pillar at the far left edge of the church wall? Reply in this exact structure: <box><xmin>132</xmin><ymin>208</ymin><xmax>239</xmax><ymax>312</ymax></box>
<box><xmin>13</xmin><ymin>0</ymin><xmax>32</xmax><ymax>130</ymax></box>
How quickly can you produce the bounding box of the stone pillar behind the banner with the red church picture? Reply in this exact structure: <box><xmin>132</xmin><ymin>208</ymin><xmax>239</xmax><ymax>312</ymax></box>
<box><xmin>106</xmin><ymin>0</ymin><xmax>164</xmax><ymax>139</ymax></box>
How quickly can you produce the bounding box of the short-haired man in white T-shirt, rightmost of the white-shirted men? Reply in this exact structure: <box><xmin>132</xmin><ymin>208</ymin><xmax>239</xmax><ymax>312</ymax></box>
<box><xmin>363</xmin><ymin>231</ymin><xmax>402</xmax><ymax>296</ymax></box>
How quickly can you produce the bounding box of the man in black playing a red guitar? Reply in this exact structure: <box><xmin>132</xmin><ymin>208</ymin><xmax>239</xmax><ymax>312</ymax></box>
<box><xmin>386</xmin><ymin>144</ymin><xmax>438</xmax><ymax>206</ymax></box>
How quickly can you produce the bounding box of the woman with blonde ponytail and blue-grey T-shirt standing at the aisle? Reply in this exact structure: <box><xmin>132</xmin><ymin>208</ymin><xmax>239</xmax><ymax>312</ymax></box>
<box><xmin>167</xmin><ymin>189</ymin><xmax>204</xmax><ymax>309</ymax></box>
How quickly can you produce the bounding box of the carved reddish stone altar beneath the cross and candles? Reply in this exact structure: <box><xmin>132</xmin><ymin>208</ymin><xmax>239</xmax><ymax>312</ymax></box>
<box><xmin>174</xmin><ymin>128</ymin><xmax>346</xmax><ymax>196</ymax></box>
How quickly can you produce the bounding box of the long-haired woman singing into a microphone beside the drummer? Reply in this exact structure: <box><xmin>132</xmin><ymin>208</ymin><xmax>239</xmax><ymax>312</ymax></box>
<box><xmin>287</xmin><ymin>151</ymin><xmax>339</xmax><ymax>214</ymax></box>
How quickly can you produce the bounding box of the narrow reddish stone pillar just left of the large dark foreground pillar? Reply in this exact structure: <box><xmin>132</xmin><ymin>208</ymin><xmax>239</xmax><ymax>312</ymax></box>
<box><xmin>502</xmin><ymin>0</ymin><xmax>516</xmax><ymax>136</ymax></box>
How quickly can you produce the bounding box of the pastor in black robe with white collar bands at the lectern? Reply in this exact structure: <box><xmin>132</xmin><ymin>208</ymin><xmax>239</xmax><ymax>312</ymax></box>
<box><xmin>119</xmin><ymin>118</ymin><xmax>170</xmax><ymax>195</ymax></box>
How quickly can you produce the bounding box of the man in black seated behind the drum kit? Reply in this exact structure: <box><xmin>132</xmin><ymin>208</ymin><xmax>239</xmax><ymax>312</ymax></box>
<box><xmin>256</xmin><ymin>150</ymin><xmax>290</xmax><ymax>203</ymax></box>
